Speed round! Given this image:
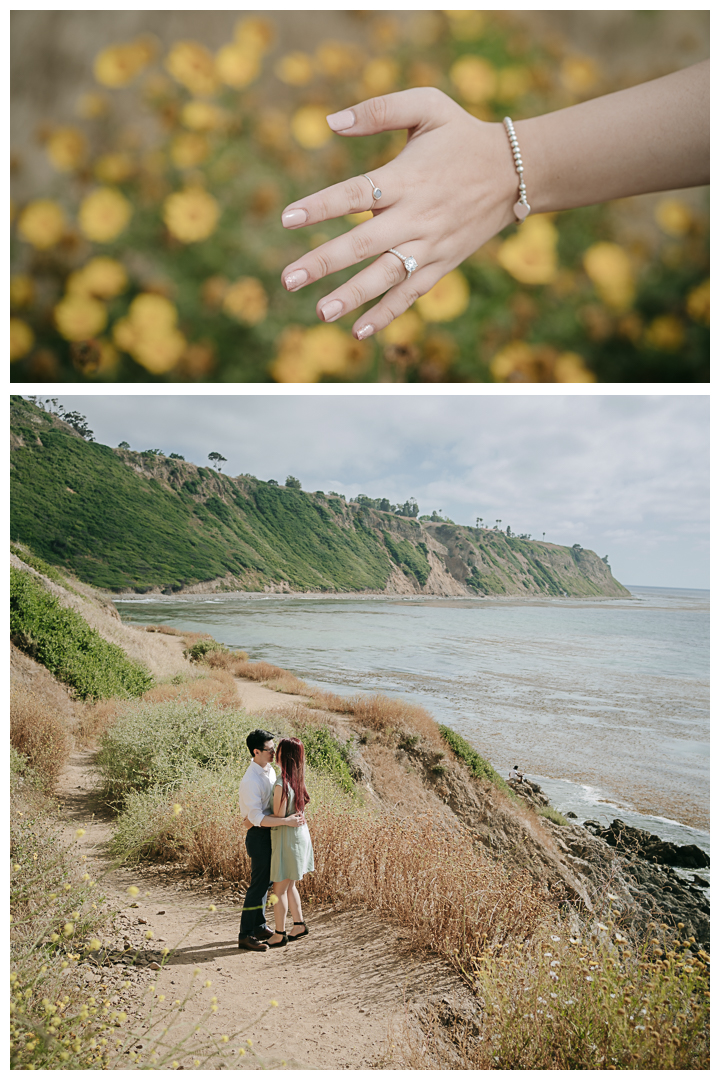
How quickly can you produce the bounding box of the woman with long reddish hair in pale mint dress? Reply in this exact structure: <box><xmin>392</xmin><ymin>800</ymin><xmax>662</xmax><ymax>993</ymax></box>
<box><xmin>268</xmin><ymin>739</ymin><xmax>315</xmax><ymax>948</ymax></box>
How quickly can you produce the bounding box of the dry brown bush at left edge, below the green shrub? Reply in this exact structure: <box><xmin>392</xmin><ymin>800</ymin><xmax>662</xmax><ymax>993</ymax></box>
<box><xmin>10</xmin><ymin>687</ymin><xmax>72</xmax><ymax>787</ymax></box>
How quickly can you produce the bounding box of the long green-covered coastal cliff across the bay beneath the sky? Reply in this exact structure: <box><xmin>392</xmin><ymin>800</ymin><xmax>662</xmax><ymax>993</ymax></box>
<box><xmin>11</xmin><ymin>397</ymin><xmax>629</xmax><ymax>597</ymax></box>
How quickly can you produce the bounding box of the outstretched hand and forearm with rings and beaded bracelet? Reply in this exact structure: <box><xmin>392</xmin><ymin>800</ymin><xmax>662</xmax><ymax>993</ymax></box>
<box><xmin>282</xmin><ymin>60</ymin><xmax>710</xmax><ymax>339</ymax></box>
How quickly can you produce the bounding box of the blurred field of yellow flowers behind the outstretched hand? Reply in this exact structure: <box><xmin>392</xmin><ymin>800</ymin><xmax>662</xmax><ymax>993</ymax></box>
<box><xmin>11</xmin><ymin>12</ymin><xmax>709</xmax><ymax>382</ymax></box>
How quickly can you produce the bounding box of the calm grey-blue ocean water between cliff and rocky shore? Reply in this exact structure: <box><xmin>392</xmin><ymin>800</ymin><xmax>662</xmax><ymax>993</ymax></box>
<box><xmin>116</xmin><ymin>586</ymin><xmax>709</xmax><ymax>868</ymax></box>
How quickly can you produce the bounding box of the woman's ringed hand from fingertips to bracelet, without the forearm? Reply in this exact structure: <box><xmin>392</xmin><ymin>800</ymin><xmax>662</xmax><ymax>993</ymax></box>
<box><xmin>282</xmin><ymin>87</ymin><xmax>520</xmax><ymax>339</ymax></box>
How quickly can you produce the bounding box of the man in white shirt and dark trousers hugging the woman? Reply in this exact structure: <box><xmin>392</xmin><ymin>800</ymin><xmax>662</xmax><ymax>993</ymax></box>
<box><xmin>237</xmin><ymin>728</ymin><xmax>305</xmax><ymax>953</ymax></box>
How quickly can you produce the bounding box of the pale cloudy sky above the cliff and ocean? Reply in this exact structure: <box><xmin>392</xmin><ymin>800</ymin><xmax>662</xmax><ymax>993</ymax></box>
<box><xmin>46</xmin><ymin>393</ymin><xmax>709</xmax><ymax>589</ymax></box>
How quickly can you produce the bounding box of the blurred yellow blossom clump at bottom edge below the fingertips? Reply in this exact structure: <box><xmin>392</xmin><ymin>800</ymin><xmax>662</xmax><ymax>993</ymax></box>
<box><xmin>269</xmin><ymin>323</ymin><xmax>366</xmax><ymax>382</ymax></box>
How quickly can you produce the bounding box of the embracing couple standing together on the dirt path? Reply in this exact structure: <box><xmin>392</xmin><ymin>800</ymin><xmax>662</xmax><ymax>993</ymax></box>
<box><xmin>237</xmin><ymin>728</ymin><xmax>315</xmax><ymax>953</ymax></box>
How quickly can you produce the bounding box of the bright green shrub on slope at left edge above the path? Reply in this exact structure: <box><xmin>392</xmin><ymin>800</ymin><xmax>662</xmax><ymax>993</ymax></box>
<box><xmin>10</xmin><ymin>567</ymin><xmax>152</xmax><ymax>701</ymax></box>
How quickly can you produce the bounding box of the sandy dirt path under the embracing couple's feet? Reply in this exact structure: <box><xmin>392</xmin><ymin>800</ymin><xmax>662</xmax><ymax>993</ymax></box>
<box><xmin>57</xmin><ymin>680</ymin><xmax>466</xmax><ymax>1069</ymax></box>
